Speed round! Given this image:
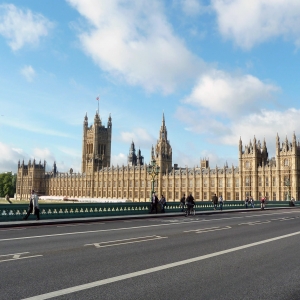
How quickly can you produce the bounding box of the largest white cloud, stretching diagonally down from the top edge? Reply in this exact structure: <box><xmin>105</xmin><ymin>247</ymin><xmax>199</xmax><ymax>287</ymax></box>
<box><xmin>68</xmin><ymin>0</ymin><xmax>204</xmax><ymax>93</ymax></box>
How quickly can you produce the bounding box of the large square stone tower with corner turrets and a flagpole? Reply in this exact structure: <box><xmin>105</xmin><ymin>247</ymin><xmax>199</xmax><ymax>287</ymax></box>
<box><xmin>81</xmin><ymin>111</ymin><xmax>112</xmax><ymax>173</ymax></box>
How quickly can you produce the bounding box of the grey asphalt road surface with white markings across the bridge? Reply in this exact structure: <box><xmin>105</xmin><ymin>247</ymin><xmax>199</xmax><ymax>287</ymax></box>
<box><xmin>0</xmin><ymin>209</ymin><xmax>300</xmax><ymax>300</ymax></box>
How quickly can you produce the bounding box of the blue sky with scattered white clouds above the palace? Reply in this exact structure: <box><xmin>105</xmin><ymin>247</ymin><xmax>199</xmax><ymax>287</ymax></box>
<box><xmin>0</xmin><ymin>0</ymin><xmax>300</xmax><ymax>172</ymax></box>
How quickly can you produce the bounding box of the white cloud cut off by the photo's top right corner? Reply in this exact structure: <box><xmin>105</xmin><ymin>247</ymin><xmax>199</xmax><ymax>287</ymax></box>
<box><xmin>212</xmin><ymin>0</ymin><xmax>300</xmax><ymax>49</ymax></box>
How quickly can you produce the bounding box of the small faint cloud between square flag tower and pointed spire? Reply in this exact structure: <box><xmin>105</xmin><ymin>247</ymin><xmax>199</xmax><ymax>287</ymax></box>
<box><xmin>120</xmin><ymin>128</ymin><xmax>156</xmax><ymax>148</ymax></box>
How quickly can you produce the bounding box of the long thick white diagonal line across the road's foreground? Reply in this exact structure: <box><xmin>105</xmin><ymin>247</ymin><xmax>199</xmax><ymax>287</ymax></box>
<box><xmin>23</xmin><ymin>231</ymin><xmax>300</xmax><ymax>300</ymax></box>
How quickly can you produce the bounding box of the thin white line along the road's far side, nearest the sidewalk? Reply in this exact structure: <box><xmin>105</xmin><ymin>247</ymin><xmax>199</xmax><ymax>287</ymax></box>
<box><xmin>4</xmin><ymin>212</ymin><xmax>300</xmax><ymax>242</ymax></box>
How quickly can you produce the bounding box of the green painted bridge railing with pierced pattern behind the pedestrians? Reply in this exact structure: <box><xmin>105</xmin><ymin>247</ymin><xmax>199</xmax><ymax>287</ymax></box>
<box><xmin>0</xmin><ymin>201</ymin><xmax>300</xmax><ymax>222</ymax></box>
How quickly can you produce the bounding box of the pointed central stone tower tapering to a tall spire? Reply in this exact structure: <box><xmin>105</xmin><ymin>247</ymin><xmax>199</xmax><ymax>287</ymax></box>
<box><xmin>152</xmin><ymin>114</ymin><xmax>172</xmax><ymax>173</ymax></box>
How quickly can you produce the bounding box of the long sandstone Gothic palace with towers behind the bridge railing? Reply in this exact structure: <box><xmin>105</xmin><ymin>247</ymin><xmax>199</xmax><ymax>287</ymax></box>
<box><xmin>16</xmin><ymin>108</ymin><xmax>300</xmax><ymax>202</ymax></box>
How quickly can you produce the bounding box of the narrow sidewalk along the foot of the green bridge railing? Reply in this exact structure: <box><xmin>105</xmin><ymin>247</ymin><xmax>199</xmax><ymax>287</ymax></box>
<box><xmin>0</xmin><ymin>207</ymin><xmax>297</xmax><ymax>228</ymax></box>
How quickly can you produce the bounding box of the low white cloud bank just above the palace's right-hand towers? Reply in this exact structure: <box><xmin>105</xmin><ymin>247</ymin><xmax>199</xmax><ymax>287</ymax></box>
<box><xmin>177</xmin><ymin>108</ymin><xmax>300</xmax><ymax>162</ymax></box>
